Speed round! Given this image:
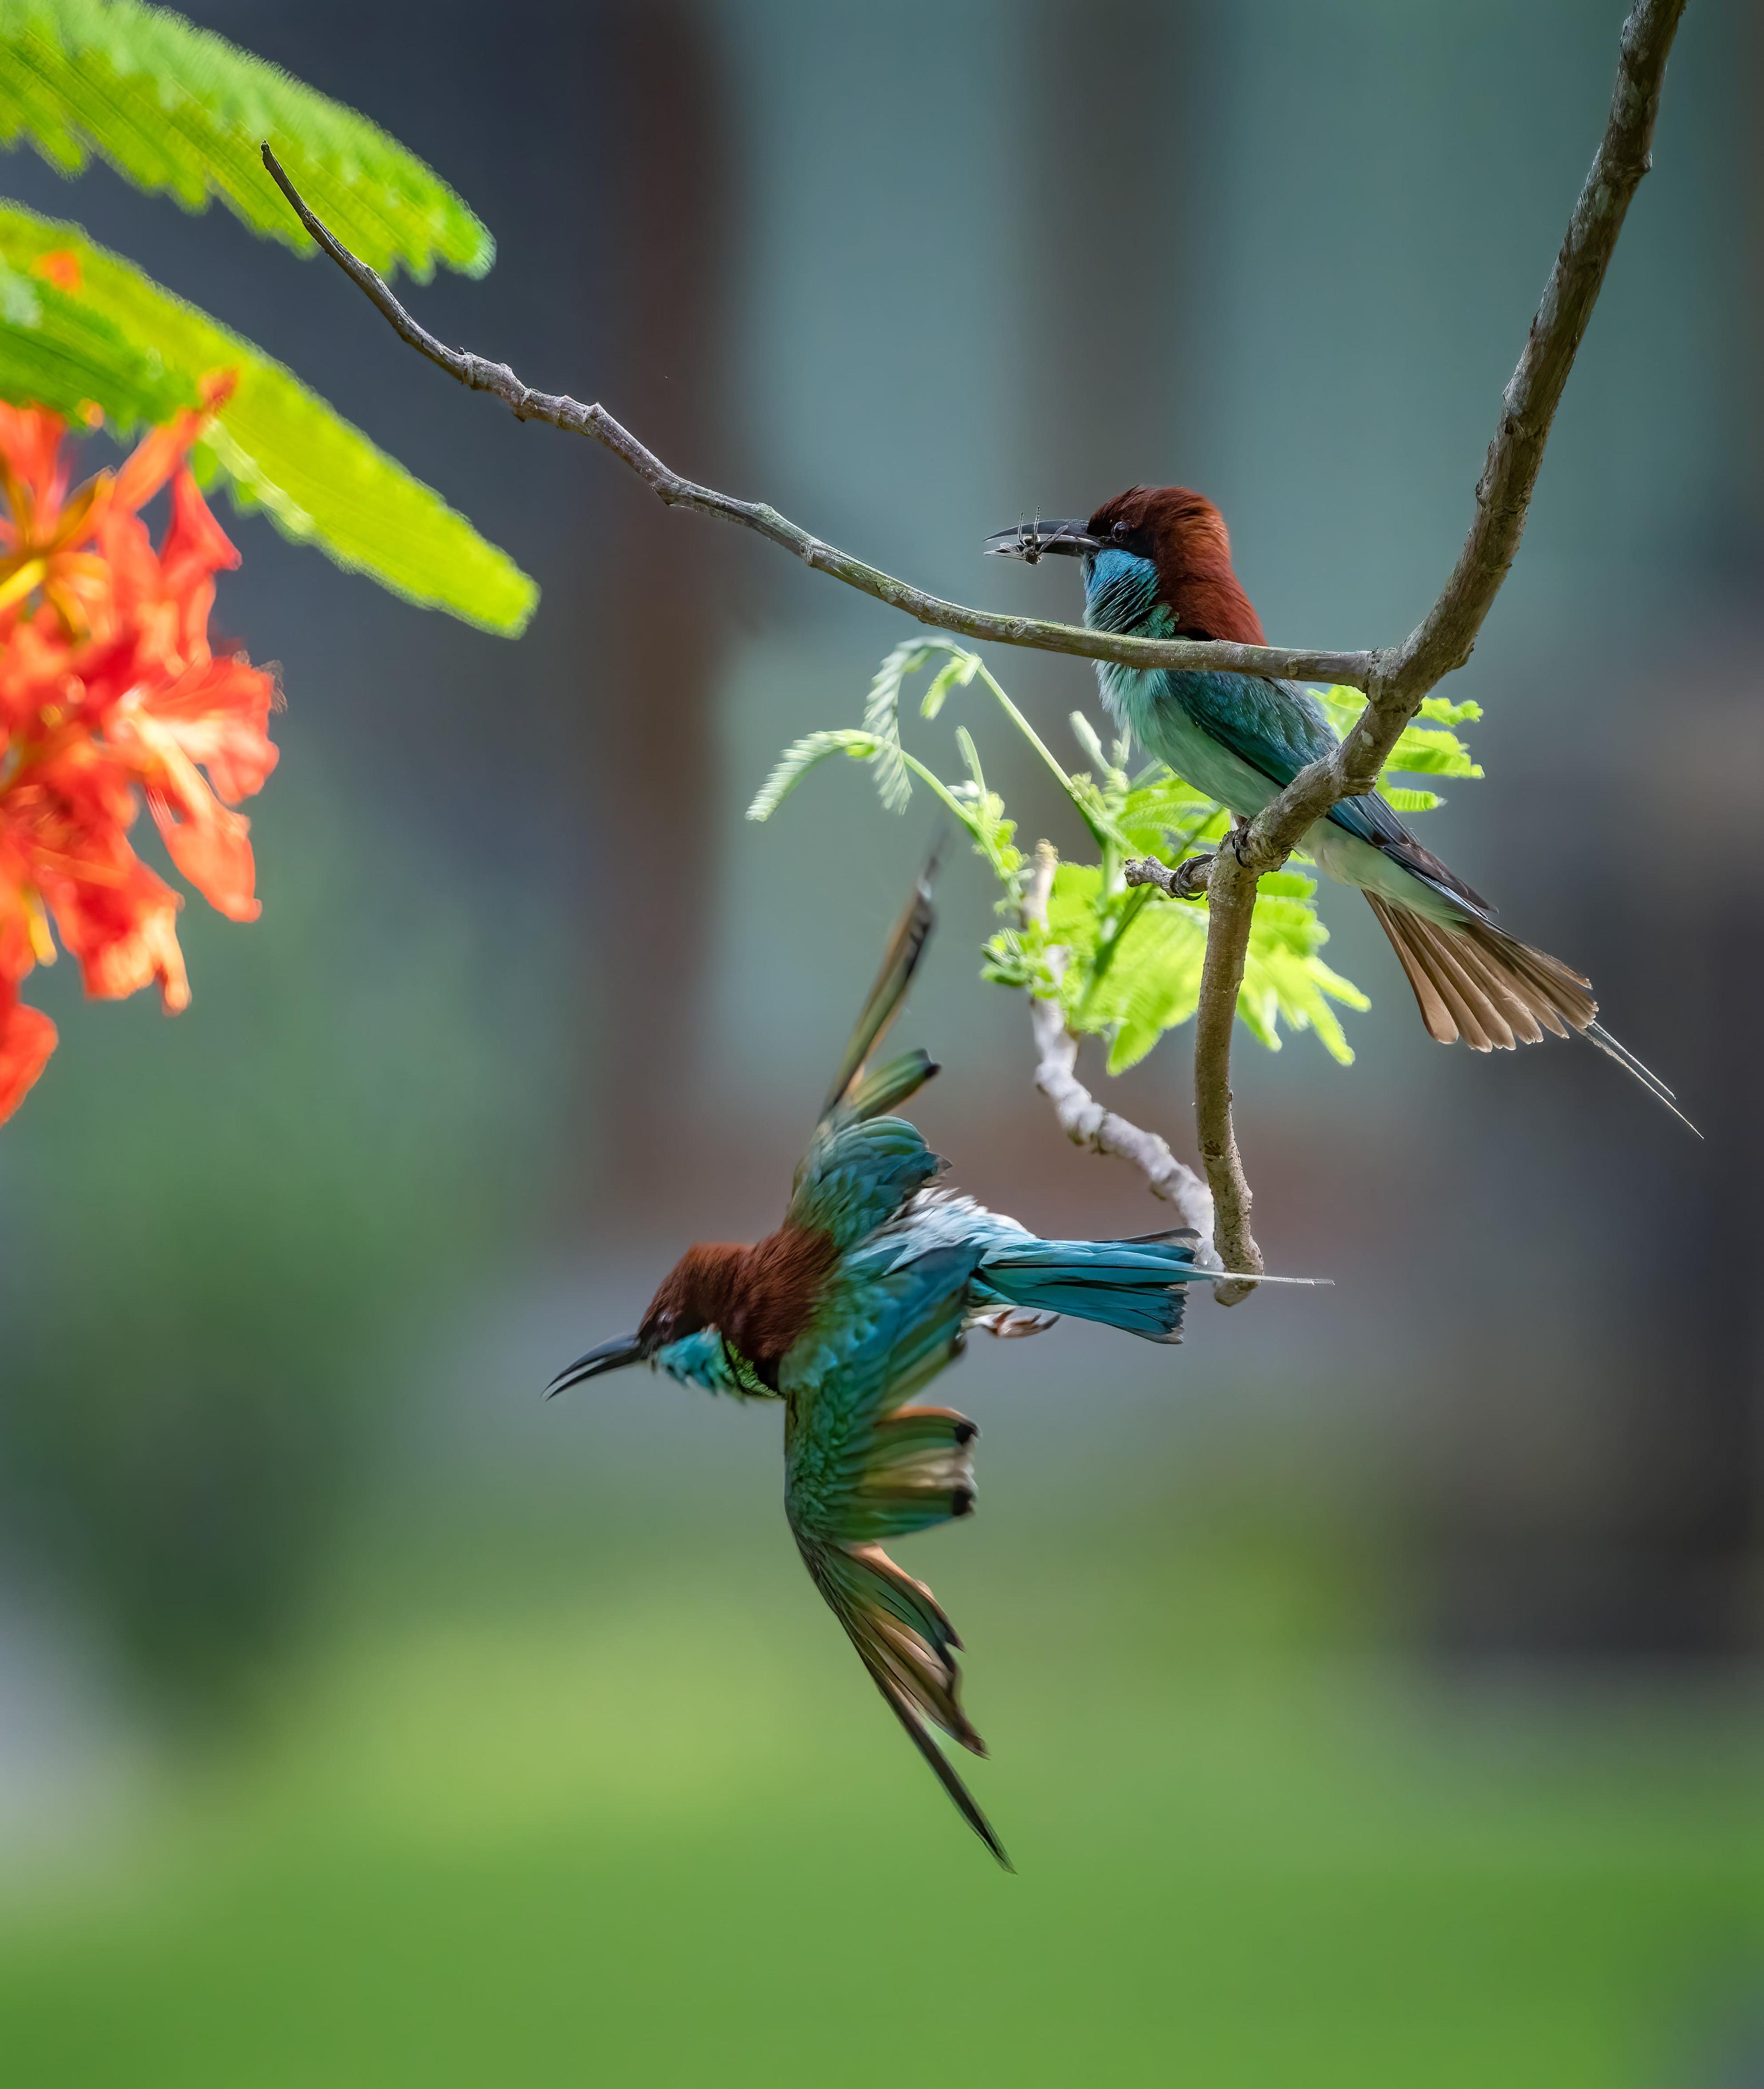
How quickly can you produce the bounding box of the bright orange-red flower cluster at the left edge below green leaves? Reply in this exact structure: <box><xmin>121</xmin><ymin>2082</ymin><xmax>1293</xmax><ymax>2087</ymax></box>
<box><xmin>0</xmin><ymin>382</ymin><xmax>276</xmax><ymax>1122</ymax></box>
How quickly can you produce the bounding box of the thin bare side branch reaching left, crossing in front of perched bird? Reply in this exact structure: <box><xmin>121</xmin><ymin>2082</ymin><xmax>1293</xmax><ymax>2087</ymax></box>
<box><xmin>263</xmin><ymin>144</ymin><xmax>1380</xmax><ymax>690</ymax></box>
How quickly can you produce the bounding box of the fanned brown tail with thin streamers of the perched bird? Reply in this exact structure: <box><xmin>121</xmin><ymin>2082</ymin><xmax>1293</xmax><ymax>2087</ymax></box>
<box><xmin>1365</xmin><ymin>892</ymin><xmax>1703</xmax><ymax>1138</ymax></box>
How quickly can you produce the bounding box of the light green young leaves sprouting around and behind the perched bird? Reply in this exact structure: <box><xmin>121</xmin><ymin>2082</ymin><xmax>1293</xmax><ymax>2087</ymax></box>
<box><xmin>747</xmin><ymin>656</ymin><xmax>1482</xmax><ymax>1074</ymax></box>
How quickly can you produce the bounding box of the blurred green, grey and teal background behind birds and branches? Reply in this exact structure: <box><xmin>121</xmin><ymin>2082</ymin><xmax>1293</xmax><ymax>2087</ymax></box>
<box><xmin>0</xmin><ymin>0</ymin><xmax>1764</xmax><ymax>2089</ymax></box>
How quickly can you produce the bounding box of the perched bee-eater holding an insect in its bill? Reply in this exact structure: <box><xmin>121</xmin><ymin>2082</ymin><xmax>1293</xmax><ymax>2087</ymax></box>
<box><xmin>985</xmin><ymin>487</ymin><xmax>1695</xmax><ymax>1130</ymax></box>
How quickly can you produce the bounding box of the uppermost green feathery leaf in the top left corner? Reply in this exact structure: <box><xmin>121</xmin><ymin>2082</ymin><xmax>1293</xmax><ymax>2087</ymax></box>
<box><xmin>0</xmin><ymin>0</ymin><xmax>495</xmax><ymax>282</ymax></box>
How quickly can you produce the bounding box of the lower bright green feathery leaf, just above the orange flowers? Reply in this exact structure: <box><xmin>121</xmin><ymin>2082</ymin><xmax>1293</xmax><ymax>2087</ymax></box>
<box><xmin>0</xmin><ymin>203</ymin><xmax>538</xmax><ymax>635</ymax></box>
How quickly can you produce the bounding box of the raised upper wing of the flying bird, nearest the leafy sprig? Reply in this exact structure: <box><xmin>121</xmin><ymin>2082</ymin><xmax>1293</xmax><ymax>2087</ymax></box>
<box><xmin>785</xmin><ymin>863</ymin><xmax>944</xmax><ymax>1249</ymax></box>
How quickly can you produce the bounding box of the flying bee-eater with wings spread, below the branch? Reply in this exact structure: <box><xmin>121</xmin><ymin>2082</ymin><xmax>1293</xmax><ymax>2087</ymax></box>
<box><xmin>549</xmin><ymin>873</ymin><xmax>1252</xmax><ymax>1868</ymax></box>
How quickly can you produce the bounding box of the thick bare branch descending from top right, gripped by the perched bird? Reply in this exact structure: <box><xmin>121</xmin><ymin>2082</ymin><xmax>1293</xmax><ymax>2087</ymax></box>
<box><xmin>1169</xmin><ymin>0</ymin><xmax>1685</xmax><ymax>1291</ymax></box>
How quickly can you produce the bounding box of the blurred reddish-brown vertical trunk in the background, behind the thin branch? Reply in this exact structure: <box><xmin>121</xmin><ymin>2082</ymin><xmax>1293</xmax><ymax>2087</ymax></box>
<box><xmin>574</xmin><ymin>0</ymin><xmax>741</xmax><ymax>1220</ymax></box>
